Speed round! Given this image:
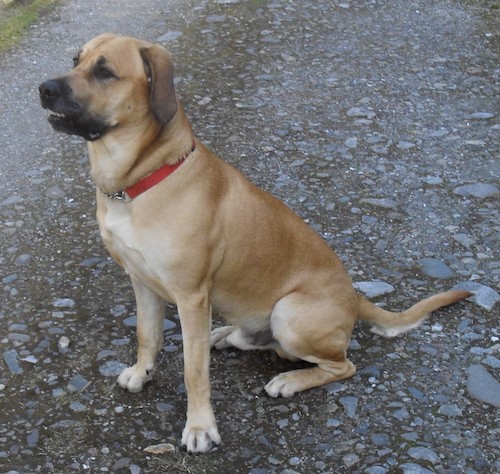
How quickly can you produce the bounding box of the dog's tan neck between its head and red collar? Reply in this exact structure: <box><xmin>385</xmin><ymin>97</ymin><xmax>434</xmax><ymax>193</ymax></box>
<box><xmin>87</xmin><ymin>108</ymin><xmax>194</xmax><ymax>193</ymax></box>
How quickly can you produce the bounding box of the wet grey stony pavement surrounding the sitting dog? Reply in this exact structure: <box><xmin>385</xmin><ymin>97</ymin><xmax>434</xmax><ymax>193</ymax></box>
<box><xmin>0</xmin><ymin>0</ymin><xmax>500</xmax><ymax>474</ymax></box>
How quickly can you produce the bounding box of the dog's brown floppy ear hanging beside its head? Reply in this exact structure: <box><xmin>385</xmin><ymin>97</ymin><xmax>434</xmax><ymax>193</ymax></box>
<box><xmin>140</xmin><ymin>45</ymin><xmax>178</xmax><ymax>124</ymax></box>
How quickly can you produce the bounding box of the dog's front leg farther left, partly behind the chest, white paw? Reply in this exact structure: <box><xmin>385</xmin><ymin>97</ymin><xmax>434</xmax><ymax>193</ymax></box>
<box><xmin>118</xmin><ymin>277</ymin><xmax>165</xmax><ymax>392</ymax></box>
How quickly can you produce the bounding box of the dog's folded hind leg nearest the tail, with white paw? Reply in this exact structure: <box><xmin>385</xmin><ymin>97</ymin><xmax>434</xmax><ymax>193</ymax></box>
<box><xmin>265</xmin><ymin>294</ymin><xmax>356</xmax><ymax>397</ymax></box>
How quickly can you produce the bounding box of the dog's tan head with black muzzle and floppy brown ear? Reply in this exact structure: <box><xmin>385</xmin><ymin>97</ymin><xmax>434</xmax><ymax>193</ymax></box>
<box><xmin>39</xmin><ymin>34</ymin><xmax>178</xmax><ymax>141</ymax></box>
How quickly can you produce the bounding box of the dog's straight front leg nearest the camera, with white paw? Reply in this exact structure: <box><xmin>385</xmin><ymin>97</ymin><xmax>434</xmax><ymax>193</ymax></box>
<box><xmin>178</xmin><ymin>295</ymin><xmax>221</xmax><ymax>453</ymax></box>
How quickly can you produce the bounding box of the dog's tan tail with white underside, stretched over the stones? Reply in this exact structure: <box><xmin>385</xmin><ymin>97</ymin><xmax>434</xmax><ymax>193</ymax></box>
<box><xmin>358</xmin><ymin>291</ymin><xmax>473</xmax><ymax>337</ymax></box>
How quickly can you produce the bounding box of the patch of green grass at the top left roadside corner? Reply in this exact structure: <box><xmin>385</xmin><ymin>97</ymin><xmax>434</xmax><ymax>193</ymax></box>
<box><xmin>0</xmin><ymin>0</ymin><xmax>57</xmax><ymax>51</ymax></box>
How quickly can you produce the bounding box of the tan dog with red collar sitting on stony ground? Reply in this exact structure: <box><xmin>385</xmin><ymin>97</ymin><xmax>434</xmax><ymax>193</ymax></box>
<box><xmin>40</xmin><ymin>34</ymin><xmax>470</xmax><ymax>452</ymax></box>
